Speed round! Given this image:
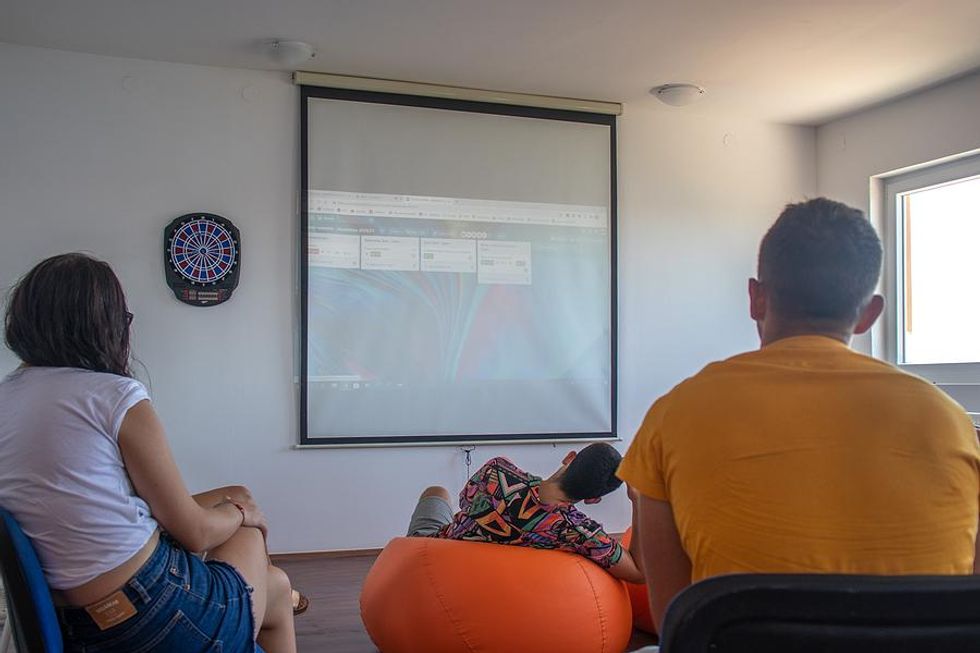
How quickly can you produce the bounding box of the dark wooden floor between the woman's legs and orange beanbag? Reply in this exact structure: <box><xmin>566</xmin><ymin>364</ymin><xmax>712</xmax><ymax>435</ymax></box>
<box><xmin>276</xmin><ymin>555</ymin><xmax>656</xmax><ymax>653</ymax></box>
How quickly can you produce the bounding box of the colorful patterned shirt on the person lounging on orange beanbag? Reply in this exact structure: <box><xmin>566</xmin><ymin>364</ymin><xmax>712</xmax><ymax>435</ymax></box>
<box><xmin>433</xmin><ymin>458</ymin><xmax>623</xmax><ymax>569</ymax></box>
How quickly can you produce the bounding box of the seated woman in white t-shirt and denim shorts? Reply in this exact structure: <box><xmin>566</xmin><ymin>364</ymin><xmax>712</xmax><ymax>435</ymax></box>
<box><xmin>0</xmin><ymin>254</ymin><xmax>296</xmax><ymax>653</ymax></box>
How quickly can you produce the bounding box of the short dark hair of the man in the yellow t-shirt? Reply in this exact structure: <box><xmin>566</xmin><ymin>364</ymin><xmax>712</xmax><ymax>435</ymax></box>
<box><xmin>759</xmin><ymin>197</ymin><xmax>881</xmax><ymax>327</ymax></box>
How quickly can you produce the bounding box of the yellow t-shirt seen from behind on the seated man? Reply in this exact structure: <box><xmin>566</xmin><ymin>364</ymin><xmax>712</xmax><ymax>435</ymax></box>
<box><xmin>618</xmin><ymin>336</ymin><xmax>980</xmax><ymax>581</ymax></box>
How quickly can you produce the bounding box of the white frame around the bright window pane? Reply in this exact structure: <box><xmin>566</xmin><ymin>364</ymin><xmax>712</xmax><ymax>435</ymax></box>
<box><xmin>880</xmin><ymin>150</ymin><xmax>980</xmax><ymax>385</ymax></box>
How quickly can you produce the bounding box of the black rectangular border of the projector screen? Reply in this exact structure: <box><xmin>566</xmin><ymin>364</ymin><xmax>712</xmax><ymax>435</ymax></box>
<box><xmin>294</xmin><ymin>84</ymin><xmax>620</xmax><ymax>449</ymax></box>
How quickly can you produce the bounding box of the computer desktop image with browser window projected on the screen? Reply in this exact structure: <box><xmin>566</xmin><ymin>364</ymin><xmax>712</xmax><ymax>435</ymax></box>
<box><xmin>307</xmin><ymin>190</ymin><xmax>611</xmax><ymax>437</ymax></box>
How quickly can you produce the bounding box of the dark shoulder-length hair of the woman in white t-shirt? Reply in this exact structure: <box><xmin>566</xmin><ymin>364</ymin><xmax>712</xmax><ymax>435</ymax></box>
<box><xmin>4</xmin><ymin>254</ymin><xmax>132</xmax><ymax>376</ymax></box>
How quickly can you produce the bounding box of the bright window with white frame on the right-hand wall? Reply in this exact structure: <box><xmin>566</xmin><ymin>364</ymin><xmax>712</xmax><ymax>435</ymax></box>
<box><xmin>885</xmin><ymin>150</ymin><xmax>980</xmax><ymax>370</ymax></box>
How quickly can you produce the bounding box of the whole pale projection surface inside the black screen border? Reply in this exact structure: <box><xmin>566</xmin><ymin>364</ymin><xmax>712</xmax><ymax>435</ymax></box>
<box><xmin>302</xmin><ymin>97</ymin><xmax>615</xmax><ymax>444</ymax></box>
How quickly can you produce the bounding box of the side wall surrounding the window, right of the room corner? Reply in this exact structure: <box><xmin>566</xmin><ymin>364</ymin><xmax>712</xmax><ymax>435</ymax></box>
<box><xmin>817</xmin><ymin>73</ymin><xmax>980</xmax><ymax>352</ymax></box>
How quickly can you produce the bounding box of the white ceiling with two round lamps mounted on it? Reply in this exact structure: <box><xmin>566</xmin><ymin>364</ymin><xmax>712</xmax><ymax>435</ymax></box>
<box><xmin>0</xmin><ymin>0</ymin><xmax>980</xmax><ymax>124</ymax></box>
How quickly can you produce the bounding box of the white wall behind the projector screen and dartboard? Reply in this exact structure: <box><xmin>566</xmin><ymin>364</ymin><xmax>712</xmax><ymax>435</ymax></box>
<box><xmin>0</xmin><ymin>44</ymin><xmax>816</xmax><ymax>551</ymax></box>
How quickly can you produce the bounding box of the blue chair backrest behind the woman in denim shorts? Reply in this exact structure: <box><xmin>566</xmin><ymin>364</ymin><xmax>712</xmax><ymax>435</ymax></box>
<box><xmin>0</xmin><ymin>508</ymin><xmax>63</xmax><ymax>653</ymax></box>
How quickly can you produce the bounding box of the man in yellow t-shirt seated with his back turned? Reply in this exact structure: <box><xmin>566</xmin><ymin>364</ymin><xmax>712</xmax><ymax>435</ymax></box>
<box><xmin>618</xmin><ymin>198</ymin><xmax>980</xmax><ymax>624</ymax></box>
